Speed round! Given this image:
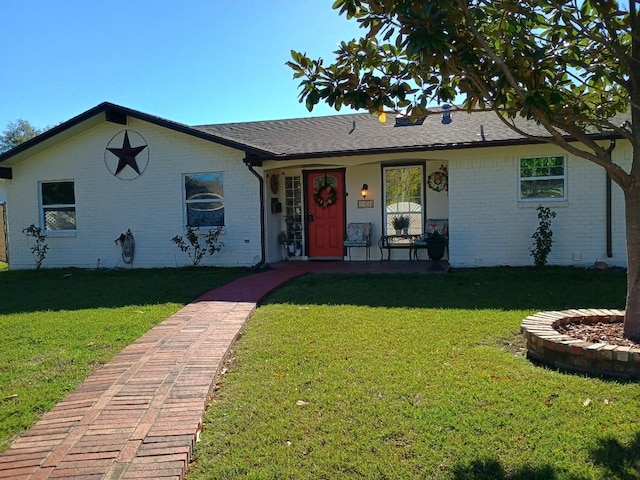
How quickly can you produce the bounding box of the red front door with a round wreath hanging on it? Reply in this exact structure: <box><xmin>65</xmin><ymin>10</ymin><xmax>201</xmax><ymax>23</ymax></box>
<box><xmin>304</xmin><ymin>170</ymin><xmax>345</xmax><ymax>258</ymax></box>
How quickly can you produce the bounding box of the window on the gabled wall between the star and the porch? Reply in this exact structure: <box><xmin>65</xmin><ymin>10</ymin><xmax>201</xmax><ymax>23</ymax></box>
<box><xmin>184</xmin><ymin>172</ymin><xmax>224</xmax><ymax>228</ymax></box>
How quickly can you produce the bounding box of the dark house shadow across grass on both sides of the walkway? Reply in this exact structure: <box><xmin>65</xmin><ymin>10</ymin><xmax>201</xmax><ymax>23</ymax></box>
<box><xmin>0</xmin><ymin>267</ymin><xmax>626</xmax><ymax>314</ymax></box>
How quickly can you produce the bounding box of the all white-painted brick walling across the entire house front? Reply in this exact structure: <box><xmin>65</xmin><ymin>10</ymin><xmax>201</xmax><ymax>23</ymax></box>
<box><xmin>3</xmin><ymin>113</ymin><xmax>631</xmax><ymax>269</ymax></box>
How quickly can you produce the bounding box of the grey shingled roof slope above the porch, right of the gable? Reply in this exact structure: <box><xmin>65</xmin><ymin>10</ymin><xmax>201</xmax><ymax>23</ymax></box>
<box><xmin>192</xmin><ymin>111</ymin><xmax>560</xmax><ymax>159</ymax></box>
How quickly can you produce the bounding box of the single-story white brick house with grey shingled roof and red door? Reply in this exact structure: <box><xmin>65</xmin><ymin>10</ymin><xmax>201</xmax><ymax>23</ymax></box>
<box><xmin>0</xmin><ymin>103</ymin><xmax>631</xmax><ymax>269</ymax></box>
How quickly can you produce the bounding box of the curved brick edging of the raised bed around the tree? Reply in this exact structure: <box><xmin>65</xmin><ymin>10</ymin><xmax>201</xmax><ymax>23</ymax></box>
<box><xmin>520</xmin><ymin>309</ymin><xmax>640</xmax><ymax>380</ymax></box>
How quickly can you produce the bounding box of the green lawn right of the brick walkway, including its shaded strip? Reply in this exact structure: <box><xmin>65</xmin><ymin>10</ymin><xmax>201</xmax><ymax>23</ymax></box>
<box><xmin>188</xmin><ymin>268</ymin><xmax>640</xmax><ymax>480</ymax></box>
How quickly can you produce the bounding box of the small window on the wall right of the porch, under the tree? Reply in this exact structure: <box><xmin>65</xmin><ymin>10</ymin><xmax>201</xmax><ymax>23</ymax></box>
<box><xmin>518</xmin><ymin>155</ymin><xmax>566</xmax><ymax>201</ymax></box>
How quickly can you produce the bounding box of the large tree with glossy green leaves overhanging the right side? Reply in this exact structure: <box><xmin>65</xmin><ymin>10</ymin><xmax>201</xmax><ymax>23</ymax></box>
<box><xmin>288</xmin><ymin>0</ymin><xmax>640</xmax><ymax>340</ymax></box>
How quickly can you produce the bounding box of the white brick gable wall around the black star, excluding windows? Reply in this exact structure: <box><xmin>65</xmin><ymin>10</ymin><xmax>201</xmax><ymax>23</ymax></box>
<box><xmin>7</xmin><ymin>119</ymin><xmax>260</xmax><ymax>269</ymax></box>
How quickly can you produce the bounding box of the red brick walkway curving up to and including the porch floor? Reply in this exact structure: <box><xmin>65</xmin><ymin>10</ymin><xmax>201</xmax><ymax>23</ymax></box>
<box><xmin>0</xmin><ymin>262</ymin><xmax>448</xmax><ymax>480</ymax></box>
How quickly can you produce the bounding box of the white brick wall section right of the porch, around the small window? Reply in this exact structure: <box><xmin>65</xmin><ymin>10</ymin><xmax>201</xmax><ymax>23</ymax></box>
<box><xmin>449</xmin><ymin>145</ymin><xmax>626</xmax><ymax>267</ymax></box>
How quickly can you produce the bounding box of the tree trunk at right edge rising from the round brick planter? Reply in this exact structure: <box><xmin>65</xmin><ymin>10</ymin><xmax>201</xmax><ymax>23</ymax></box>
<box><xmin>624</xmin><ymin>182</ymin><xmax>640</xmax><ymax>341</ymax></box>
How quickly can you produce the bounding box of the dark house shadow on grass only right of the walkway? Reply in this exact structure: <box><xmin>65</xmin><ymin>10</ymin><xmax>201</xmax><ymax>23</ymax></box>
<box><xmin>264</xmin><ymin>267</ymin><xmax>626</xmax><ymax>310</ymax></box>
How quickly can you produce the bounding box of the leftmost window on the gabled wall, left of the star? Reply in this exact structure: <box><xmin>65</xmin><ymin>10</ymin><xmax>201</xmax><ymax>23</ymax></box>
<box><xmin>40</xmin><ymin>181</ymin><xmax>76</xmax><ymax>232</ymax></box>
